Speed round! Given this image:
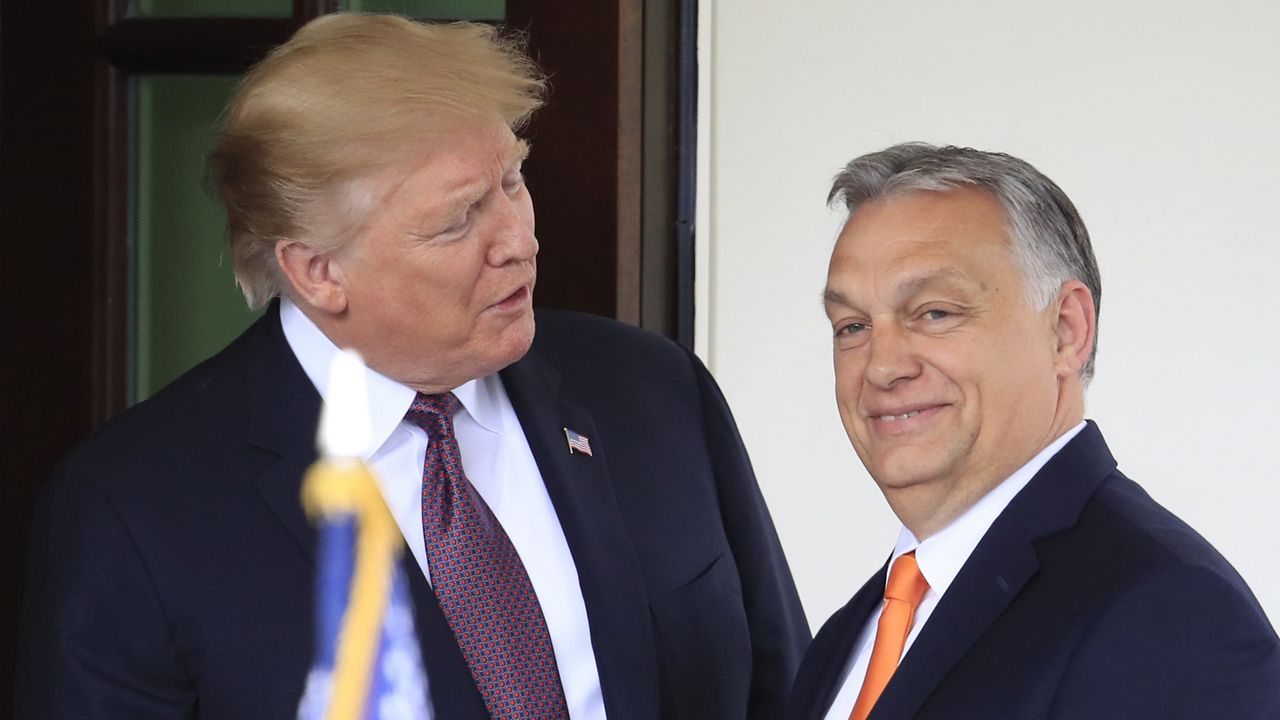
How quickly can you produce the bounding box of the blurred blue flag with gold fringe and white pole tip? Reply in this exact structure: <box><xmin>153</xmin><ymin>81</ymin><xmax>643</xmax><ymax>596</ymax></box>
<box><xmin>298</xmin><ymin>354</ymin><xmax>430</xmax><ymax>720</ymax></box>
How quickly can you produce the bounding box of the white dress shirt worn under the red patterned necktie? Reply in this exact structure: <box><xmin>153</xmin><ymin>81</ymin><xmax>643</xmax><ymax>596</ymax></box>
<box><xmin>280</xmin><ymin>299</ymin><xmax>604</xmax><ymax>720</ymax></box>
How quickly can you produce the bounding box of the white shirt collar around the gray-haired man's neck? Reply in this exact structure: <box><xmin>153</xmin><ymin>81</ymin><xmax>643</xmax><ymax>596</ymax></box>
<box><xmin>890</xmin><ymin>420</ymin><xmax>1085</xmax><ymax>597</ymax></box>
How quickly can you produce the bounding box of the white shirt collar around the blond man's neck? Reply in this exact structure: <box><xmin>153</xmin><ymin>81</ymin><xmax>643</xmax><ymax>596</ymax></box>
<box><xmin>280</xmin><ymin>297</ymin><xmax>504</xmax><ymax>460</ymax></box>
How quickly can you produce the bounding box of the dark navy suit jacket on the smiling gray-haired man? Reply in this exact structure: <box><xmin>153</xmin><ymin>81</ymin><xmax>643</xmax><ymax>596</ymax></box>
<box><xmin>786</xmin><ymin>421</ymin><xmax>1280</xmax><ymax>720</ymax></box>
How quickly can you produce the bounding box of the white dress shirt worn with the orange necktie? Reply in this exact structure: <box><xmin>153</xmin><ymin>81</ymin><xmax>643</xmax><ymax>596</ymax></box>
<box><xmin>827</xmin><ymin>421</ymin><xmax>1084</xmax><ymax>720</ymax></box>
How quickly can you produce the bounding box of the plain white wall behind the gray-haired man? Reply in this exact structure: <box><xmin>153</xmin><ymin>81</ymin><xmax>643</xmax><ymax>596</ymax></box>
<box><xmin>698</xmin><ymin>0</ymin><xmax>1280</xmax><ymax>628</ymax></box>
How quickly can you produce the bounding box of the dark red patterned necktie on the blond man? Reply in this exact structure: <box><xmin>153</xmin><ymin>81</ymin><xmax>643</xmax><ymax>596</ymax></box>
<box><xmin>406</xmin><ymin>392</ymin><xmax>568</xmax><ymax>720</ymax></box>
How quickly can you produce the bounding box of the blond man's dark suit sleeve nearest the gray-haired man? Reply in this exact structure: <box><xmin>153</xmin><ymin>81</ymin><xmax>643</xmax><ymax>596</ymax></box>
<box><xmin>694</xmin><ymin>359</ymin><xmax>810</xmax><ymax>719</ymax></box>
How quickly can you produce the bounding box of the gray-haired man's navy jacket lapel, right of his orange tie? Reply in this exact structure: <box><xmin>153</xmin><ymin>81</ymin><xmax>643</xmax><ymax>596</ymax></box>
<box><xmin>868</xmin><ymin>420</ymin><xmax>1116</xmax><ymax>720</ymax></box>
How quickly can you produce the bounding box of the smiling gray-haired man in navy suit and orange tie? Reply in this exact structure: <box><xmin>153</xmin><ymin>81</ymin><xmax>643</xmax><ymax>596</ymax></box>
<box><xmin>787</xmin><ymin>143</ymin><xmax>1280</xmax><ymax>720</ymax></box>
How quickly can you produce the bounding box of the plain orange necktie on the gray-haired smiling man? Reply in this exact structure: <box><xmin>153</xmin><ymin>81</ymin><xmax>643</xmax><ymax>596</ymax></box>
<box><xmin>849</xmin><ymin>551</ymin><xmax>929</xmax><ymax>720</ymax></box>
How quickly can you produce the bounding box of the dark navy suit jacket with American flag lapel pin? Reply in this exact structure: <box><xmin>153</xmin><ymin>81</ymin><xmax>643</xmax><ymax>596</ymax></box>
<box><xmin>17</xmin><ymin>306</ymin><xmax>809</xmax><ymax>720</ymax></box>
